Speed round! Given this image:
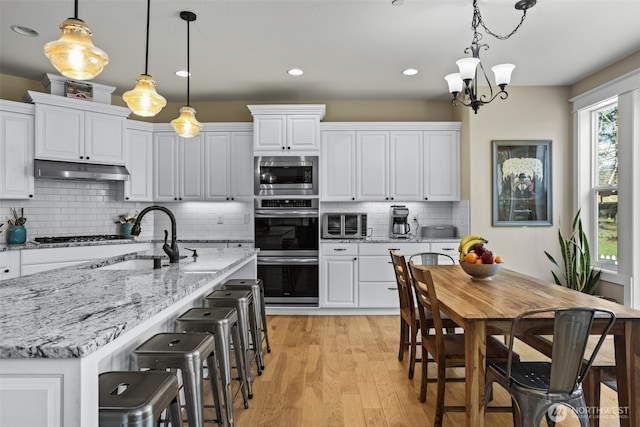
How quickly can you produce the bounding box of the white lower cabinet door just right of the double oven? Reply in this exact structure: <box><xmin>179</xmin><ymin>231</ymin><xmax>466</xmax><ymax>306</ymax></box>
<box><xmin>320</xmin><ymin>256</ymin><xmax>358</xmax><ymax>307</ymax></box>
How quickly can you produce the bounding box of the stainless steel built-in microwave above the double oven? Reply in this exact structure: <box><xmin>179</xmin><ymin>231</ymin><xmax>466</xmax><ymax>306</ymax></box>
<box><xmin>254</xmin><ymin>156</ymin><xmax>318</xmax><ymax>196</ymax></box>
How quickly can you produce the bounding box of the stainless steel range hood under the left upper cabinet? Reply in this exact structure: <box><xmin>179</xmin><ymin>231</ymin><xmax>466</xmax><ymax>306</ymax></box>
<box><xmin>34</xmin><ymin>159</ymin><xmax>129</xmax><ymax>181</ymax></box>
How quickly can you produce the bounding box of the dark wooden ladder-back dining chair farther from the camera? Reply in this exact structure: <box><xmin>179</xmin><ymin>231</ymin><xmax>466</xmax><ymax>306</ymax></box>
<box><xmin>389</xmin><ymin>250</ymin><xmax>458</xmax><ymax>379</ymax></box>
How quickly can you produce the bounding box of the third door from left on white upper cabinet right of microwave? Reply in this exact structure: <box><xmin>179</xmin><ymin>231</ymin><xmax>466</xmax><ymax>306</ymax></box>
<box><xmin>389</xmin><ymin>131</ymin><xmax>423</xmax><ymax>202</ymax></box>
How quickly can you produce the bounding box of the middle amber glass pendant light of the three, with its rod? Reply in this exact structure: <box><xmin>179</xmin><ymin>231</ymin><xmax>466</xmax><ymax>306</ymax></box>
<box><xmin>122</xmin><ymin>0</ymin><xmax>167</xmax><ymax>117</ymax></box>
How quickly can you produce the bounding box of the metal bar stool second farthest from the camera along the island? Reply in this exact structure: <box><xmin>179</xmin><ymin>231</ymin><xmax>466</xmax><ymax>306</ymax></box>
<box><xmin>204</xmin><ymin>289</ymin><xmax>264</xmax><ymax>390</ymax></box>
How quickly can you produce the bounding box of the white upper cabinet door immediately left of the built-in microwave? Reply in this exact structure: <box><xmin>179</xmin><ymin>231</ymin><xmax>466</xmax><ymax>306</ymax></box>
<box><xmin>229</xmin><ymin>132</ymin><xmax>253</xmax><ymax>200</ymax></box>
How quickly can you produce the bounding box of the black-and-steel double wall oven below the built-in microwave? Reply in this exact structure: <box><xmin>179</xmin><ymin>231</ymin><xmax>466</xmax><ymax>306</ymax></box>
<box><xmin>254</xmin><ymin>199</ymin><xmax>319</xmax><ymax>306</ymax></box>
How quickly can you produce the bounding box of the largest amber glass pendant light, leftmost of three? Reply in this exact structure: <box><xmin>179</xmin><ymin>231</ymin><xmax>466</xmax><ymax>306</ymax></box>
<box><xmin>44</xmin><ymin>0</ymin><xmax>109</xmax><ymax>80</ymax></box>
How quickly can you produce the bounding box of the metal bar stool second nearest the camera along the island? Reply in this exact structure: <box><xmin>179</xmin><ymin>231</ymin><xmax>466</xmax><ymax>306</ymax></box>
<box><xmin>132</xmin><ymin>332</ymin><xmax>223</xmax><ymax>427</ymax></box>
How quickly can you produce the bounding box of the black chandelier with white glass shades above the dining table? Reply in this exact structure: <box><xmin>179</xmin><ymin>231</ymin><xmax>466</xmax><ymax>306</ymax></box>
<box><xmin>445</xmin><ymin>0</ymin><xmax>536</xmax><ymax>114</ymax></box>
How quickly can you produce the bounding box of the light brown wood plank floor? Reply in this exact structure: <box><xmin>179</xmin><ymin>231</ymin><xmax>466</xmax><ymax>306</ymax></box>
<box><xmin>214</xmin><ymin>315</ymin><xmax>619</xmax><ymax>427</ymax></box>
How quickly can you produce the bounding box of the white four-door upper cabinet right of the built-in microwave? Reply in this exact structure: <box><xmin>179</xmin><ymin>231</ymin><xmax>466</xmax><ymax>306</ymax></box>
<box><xmin>321</xmin><ymin>122</ymin><xmax>460</xmax><ymax>202</ymax></box>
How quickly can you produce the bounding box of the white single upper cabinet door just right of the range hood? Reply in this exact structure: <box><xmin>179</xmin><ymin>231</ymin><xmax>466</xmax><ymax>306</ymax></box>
<box><xmin>124</xmin><ymin>129</ymin><xmax>153</xmax><ymax>202</ymax></box>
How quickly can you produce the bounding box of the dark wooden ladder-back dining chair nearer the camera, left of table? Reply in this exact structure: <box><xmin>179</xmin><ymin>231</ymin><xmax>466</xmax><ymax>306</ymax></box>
<box><xmin>409</xmin><ymin>261</ymin><xmax>517</xmax><ymax>427</ymax></box>
